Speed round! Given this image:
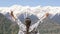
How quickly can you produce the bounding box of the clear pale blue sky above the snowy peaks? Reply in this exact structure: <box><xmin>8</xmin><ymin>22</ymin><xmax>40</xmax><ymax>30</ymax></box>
<box><xmin>0</xmin><ymin>0</ymin><xmax>60</xmax><ymax>7</ymax></box>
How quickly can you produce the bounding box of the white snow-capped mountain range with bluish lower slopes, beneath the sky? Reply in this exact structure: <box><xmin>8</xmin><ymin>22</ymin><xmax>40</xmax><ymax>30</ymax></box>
<box><xmin>0</xmin><ymin>5</ymin><xmax>60</xmax><ymax>22</ymax></box>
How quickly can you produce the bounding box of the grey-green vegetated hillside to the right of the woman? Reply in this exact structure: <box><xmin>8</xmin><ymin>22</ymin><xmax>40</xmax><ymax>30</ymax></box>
<box><xmin>39</xmin><ymin>19</ymin><xmax>60</xmax><ymax>34</ymax></box>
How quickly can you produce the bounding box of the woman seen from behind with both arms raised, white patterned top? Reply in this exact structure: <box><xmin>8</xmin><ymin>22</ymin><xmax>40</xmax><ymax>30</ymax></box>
<box><xmin>11</xmin><ymin>12</ymin><xmax>49</xmax><ymax>34</ymax></box>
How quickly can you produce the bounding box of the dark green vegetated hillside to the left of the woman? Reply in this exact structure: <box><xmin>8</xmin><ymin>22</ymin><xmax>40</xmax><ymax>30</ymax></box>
<box><xmin>0</xmin><ymin>14</ymin><xmax>19</xmax><ymax>34</ymax></box>
